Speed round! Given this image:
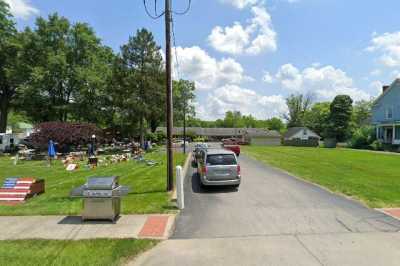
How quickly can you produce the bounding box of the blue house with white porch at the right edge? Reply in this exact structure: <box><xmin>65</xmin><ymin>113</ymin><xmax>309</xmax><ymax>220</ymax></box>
<box><xmin>372</xmin><ymin>79</ymin><xmax>400</xmax><ymax>145</ymax></box>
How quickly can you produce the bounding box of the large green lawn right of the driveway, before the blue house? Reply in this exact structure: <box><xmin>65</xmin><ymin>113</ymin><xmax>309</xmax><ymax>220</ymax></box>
<box><xmin>243</xmin><ymin>146</ymin><xmax>400</xmax><ymax>208</ymax></box>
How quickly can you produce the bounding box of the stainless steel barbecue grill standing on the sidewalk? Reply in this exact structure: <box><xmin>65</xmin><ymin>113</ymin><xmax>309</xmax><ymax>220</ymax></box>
<box><xmin>71</xmin><ymin>176</ymin><xmax>129</xmax><ymax>221</ymax></box>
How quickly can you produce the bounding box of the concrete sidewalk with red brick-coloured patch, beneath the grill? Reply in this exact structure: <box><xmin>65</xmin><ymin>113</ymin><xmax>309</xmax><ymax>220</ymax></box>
<box><xmin>0</xmin><ymin>214</ymin><xmax>175</xmax><ymax>240</ymax></box>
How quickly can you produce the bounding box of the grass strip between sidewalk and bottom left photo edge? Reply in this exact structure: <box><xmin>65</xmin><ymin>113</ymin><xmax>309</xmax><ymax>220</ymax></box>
<box><xmin>0</xmin><ymin>239</ymin><xmax>158</xmax><ymax>266</ymax></box>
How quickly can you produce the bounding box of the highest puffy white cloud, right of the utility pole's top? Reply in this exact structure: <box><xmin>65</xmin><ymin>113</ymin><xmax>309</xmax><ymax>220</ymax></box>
<box><xmin>208</xmin><ymin>6</ymin><xmax>277</xmax><ymax>55</ymax></box>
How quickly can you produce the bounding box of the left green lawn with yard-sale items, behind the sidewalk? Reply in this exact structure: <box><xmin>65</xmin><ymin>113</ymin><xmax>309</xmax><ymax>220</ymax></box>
<box><xmin>0</xmin><ymin>152</ymin><xmax>185</xmax><ymax>215</ymax></box>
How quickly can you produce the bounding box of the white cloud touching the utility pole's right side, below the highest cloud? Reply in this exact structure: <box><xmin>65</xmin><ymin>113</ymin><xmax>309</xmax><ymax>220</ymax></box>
<box><xmin>173</xmin><ymin>46</ymin><xmax>251</xmax><ymax>90</ymax></box>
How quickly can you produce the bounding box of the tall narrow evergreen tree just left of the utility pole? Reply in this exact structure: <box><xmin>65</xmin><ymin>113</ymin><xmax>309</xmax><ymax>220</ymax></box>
<box><xmin>121</xmin><ymin>29</ymin><xmax>165</xmax><ymax>145</ymax></box>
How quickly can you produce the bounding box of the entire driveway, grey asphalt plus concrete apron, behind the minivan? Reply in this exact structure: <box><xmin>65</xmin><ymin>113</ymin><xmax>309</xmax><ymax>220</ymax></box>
<box><xmin>137</xmin><ymin>153</ymin><xmax>400</xmax><ymax>265</ymax></box>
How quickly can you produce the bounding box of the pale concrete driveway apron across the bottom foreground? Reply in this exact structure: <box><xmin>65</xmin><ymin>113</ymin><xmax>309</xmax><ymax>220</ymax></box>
<box><xmin>133</xmin><ymin>232</ymin><xmax>400</xmax><ymax>266</ymax></box>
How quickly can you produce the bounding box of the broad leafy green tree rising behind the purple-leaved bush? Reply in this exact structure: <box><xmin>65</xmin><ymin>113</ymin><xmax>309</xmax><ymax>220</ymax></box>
<box><xmin>21</xmin><ymin>14</ymin><xmax>113</xmax><ymax>123</ymax></box>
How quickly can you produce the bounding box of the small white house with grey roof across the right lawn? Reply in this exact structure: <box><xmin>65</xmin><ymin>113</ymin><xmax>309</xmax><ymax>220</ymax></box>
<box><xmin>283</xmin><ymin>127</ymin><xmax>321</xmax><ymax>147</ymax></box>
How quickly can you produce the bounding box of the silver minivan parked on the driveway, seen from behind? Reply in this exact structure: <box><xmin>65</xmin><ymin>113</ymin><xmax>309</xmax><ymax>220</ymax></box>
<box><xmin>197</xmin><ymin>149</ymin><xmax>241</xmax><ymax>187</ymax></box>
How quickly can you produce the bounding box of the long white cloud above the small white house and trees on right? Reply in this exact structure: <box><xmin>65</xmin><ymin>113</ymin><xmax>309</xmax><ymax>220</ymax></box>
<box><xmin>275</xmin><ymin>64</ymin><xmax>371</xmax><ymax>101</ymax></box>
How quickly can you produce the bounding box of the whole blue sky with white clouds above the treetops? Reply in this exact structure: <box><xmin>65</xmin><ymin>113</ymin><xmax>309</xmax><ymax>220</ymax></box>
<box><xmin>5</xmin><ymin>0</ymin><xmax>400</xmax><ymax>120</ymax></box>
